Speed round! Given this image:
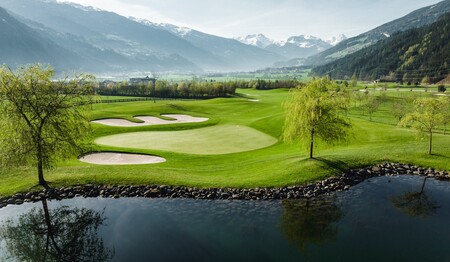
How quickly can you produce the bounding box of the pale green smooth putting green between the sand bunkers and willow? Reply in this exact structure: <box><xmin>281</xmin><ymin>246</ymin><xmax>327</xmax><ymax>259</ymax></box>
<box><xmin>95</xmin><ymin>125</ymin><xmax>277</xmax><ymax>155</ymax></box>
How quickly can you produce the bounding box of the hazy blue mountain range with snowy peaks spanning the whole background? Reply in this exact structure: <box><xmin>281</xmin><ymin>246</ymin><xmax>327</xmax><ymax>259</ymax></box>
<box><xmin>0</xmin><ymin>0</ymin><xmax>450</xmax><ymax>74</ymax></box>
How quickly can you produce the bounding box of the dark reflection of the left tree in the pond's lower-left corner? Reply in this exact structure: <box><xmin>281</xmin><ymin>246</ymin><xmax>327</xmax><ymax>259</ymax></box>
<box><xmin>0</xmin><ymin>200</ymin><xmax>114</xmax><ymax>262</ymax></box>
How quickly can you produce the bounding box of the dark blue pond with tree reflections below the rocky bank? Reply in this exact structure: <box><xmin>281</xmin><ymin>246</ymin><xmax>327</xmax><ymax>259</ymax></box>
<box><xmin>0</xmin><ymin>176</ymin><xmax>450</xmax><ymax>261</ymax></box>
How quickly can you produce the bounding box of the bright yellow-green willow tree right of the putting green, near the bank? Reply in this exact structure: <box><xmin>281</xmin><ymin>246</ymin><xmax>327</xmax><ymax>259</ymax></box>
<box><xmin>283</xmin><ymin>78</ymin><xmax>351</xmax><ymax>158</ymax></box>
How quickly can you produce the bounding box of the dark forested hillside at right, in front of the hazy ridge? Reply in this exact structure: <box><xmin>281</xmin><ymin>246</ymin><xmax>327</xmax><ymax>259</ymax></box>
<box><xmin>312</xmin><ymin>14</ymin><xmax>450</xmax><ymax>84</ymax></box>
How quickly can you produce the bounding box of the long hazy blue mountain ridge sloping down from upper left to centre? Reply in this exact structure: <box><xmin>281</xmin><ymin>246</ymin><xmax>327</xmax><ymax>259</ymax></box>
<box><xmin>0</xmin><ymin>0</ymin><xmax>282</xmax><ymax>71</ymax></box>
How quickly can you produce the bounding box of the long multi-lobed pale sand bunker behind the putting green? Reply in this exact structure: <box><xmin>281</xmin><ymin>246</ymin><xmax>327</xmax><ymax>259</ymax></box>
<box><xmin>91</xmin><ymin>114</ymin><xmax>209</xmax><ymax>127</ymax></box>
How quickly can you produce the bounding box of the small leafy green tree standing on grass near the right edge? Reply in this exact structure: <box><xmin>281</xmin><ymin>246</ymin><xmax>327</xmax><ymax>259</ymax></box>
<box><xmin>399</xmin><ymin>97</ymin><xmax>444</xmax><ymax>155</ymax></box>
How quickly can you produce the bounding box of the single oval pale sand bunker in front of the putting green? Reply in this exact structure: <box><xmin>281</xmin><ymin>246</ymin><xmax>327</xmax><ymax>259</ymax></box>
<box><xmin>79</xmin><ymin>152</ymin><xmax>166</xmax><ymax>165</ymax></box>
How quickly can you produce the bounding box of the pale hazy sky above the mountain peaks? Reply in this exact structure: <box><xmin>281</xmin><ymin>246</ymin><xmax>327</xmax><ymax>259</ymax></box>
<box><xmin>58</xmin><ymin>0</ymin><xmax>439</xmax><ymax>40</ymax></box>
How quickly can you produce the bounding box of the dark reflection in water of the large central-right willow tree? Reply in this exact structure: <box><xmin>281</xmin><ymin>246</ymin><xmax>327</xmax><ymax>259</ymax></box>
<box><xmin>280</xmin><ymin>195</ymin><xmax>343</xmax><ymax>251</ymax></box>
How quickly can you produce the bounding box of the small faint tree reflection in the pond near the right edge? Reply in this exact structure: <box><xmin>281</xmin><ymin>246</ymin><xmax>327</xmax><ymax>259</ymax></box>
<box><xmin>391</xmin><ymin>177</ymin><xmax>440</xmax><ymax>217</ymax></box>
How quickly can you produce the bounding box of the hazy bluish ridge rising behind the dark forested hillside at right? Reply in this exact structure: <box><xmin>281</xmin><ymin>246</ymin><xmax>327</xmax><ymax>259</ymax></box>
<box><xmin>305</xmin><ymin>0</ymin><xmax>450</xmax><ymax>65</ymax></box>
